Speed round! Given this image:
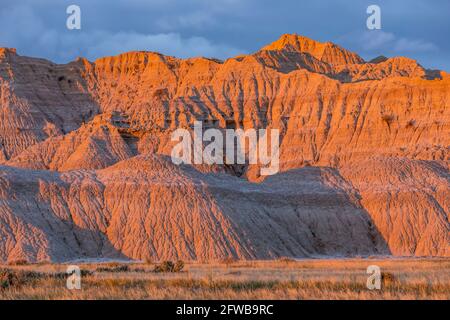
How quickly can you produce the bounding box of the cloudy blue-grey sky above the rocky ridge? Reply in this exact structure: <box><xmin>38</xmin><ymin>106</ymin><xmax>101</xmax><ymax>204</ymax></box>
<box><xmin>0</xmin><ymin>0</ymin><xmax>450</xmax><ymax>71</ymax></box>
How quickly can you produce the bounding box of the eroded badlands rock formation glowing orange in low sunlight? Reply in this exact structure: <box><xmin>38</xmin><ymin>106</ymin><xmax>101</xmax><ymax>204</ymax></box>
<box><xmin>0</xmin><ymin>35</ymin><xmax>450</xmax><ymax>261</ymax></box>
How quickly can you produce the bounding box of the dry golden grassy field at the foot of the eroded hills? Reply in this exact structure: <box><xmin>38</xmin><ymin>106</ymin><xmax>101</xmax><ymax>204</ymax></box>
<box><xmin>0</xmin><ymin>259</ymin><xmax>450</xmax><ymax>300</ymax></box>
